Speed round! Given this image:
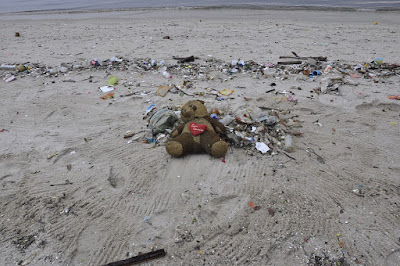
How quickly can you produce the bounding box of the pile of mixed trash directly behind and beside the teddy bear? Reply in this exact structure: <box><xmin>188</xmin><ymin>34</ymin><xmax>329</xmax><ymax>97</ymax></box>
<box><xmin>133</xmin><ymin>104</ymin><xmax>302</xmax><ymax>155</ymax></box>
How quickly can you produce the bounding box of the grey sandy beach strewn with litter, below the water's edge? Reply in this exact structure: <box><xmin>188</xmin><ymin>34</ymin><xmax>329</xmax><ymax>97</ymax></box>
<box><xmin>0</xmin><ymin>9</ymin><xmax>400</xmax><ymax>265</ymax></box>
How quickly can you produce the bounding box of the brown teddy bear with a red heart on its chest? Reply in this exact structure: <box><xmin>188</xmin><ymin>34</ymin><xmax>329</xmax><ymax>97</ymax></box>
<box><xmin>166</xmin><ymin>100</ymin><xmax>228</xmax><ymax>157</ymax></box>
